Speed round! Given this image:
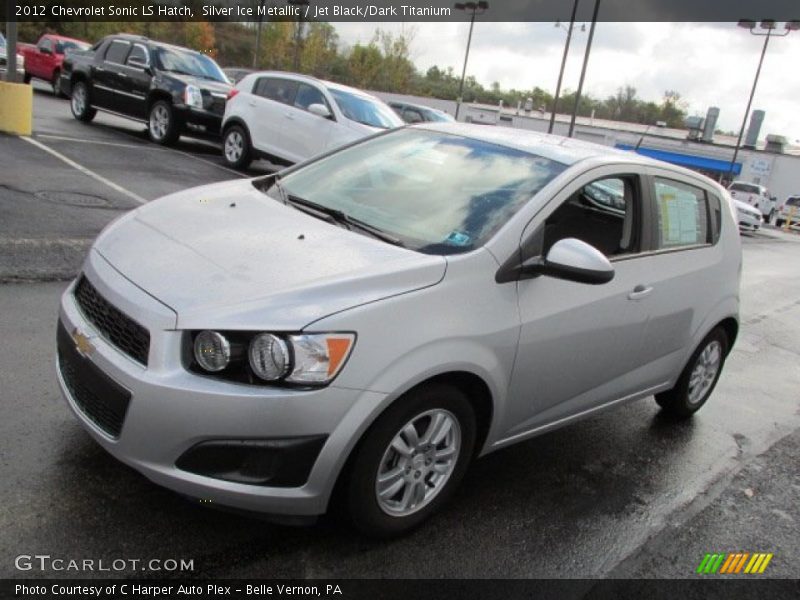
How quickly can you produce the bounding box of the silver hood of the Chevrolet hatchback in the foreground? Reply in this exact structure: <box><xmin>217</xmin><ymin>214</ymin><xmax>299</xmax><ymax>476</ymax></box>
<box><xmin>94</xmin><ymin>180</ymin><xmax>447</xmax><ymax>331</ymax></box>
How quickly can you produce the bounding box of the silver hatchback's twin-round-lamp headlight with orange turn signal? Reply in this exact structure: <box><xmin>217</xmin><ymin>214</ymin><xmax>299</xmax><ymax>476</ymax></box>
<box><xmin>190</xmin><ymin>330</ymin><xmax>356</xmax><ymax>385</ymax></box>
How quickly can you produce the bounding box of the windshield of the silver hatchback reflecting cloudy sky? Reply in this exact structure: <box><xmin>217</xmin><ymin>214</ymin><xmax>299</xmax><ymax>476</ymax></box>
<box><xmin>267</xmin><ymin>129</ymin><xmax>566</xmax><ymax>255</ymax></box>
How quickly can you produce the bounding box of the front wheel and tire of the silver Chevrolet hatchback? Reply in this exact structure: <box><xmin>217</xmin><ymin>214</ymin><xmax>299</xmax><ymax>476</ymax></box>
<box><xmin>345</xmin><ymin>384</ymin><xmax>476</xmax><ymax>538</ymax></box>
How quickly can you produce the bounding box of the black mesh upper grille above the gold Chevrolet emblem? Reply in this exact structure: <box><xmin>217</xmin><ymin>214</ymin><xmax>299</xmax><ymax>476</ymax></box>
<box><xmin>75</xmin><ymin>276</ymin><xmax>150</xmax><ymax>366</ymax></box>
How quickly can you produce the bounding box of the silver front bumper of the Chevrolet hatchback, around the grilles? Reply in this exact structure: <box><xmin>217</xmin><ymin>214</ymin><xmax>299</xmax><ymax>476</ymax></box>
<box><xmin>57</xmin><ymin>251</ymin><xmax>384</xmax><ymax>516</ymax></box>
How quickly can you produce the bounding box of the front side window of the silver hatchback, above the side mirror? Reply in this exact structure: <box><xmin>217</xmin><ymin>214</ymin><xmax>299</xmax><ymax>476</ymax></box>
<box><xmin>543</xmin><ymin>175</ymin><xmax>642</xmax><ymax>257</ymax></box>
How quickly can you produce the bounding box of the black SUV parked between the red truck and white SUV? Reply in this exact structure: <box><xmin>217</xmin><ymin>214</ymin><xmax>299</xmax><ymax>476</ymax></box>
<box><xmin>61</xmin><ymin>34</ymin><xmax>231</xmax><ymax>144</ymax></box>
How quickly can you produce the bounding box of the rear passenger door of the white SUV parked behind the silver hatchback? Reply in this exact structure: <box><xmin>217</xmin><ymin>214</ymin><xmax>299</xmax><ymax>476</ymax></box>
<box><xmin>246</xmin><ymin>76</ymin><xmax>298</xmax><ymax>160</ymax></box>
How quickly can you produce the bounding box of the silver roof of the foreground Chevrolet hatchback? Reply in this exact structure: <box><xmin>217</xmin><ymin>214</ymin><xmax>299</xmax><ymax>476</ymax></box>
<box><xmin>414</xmin><ymin>122</ymin><xmax>656</xmax><ymax>168</ymax></box>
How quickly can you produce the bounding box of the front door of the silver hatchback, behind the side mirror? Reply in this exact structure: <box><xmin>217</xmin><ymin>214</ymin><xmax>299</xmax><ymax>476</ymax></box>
<box><xmin>504</xmin><ymin>166</ymin><xmax>652</xmax><ymax>437</ymax></box>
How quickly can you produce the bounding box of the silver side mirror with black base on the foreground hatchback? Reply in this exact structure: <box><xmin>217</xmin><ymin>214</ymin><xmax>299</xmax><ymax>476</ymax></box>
<box><xmin>520</xmin><ymin>238</ymin><xmax>614</xmax><ymax>285</ymax></box>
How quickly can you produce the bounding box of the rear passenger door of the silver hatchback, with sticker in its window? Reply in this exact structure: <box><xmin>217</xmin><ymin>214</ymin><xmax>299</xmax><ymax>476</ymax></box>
<box><xmin>640</xmin><ymin>169</ymin><xmax>728</xmax><ymax>384</ymax></box>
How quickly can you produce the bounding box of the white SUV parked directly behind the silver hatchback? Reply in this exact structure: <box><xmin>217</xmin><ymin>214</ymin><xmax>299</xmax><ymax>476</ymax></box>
<box><xmin>222</xmin><ymin>71</ymin><xmax>403</xmax><ymax>169</ymax></box>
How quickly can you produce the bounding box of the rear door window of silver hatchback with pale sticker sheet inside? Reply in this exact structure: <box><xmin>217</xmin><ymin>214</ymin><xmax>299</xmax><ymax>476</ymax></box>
<box><xmin>654</xmin><ymin>177</ymin><xmax>714</xmax><ymax>249</ymax></box>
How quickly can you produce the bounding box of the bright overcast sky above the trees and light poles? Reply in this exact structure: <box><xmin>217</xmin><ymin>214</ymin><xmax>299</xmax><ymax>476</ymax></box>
<box><xmin>334</xmin><ymin>21</ymin><xmax>800</xmax><ymax>144</ymax></box>
